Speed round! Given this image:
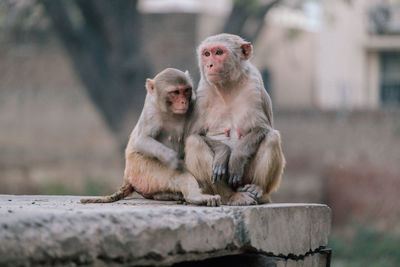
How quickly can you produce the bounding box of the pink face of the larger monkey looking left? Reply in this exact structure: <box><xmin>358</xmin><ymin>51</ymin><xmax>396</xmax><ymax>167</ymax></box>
<box><xmin>201</xmin><ymin>45</ymin><xmax>229</xmax><ymax>83</ymax></box>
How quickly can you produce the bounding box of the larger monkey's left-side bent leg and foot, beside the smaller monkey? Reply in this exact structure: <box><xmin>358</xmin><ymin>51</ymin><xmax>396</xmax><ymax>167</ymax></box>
<box><xmin>185</xmin><ymin>135</ymin><xmax>255</xmax><ymax>205</ymax></box>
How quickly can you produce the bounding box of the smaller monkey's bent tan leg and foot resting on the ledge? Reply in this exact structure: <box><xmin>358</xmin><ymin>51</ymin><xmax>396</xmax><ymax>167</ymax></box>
<box><xmin>125</xmin><ymin>153</ymin><xmax>220</xmax><ymax>206</ymax></box>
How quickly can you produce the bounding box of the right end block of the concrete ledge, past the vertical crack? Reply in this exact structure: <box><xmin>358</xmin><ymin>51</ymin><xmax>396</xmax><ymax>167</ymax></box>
<box><xmin>245</xmin><ymin>204</ymin><xmax>331</xmax><ymax>257</ymax></box>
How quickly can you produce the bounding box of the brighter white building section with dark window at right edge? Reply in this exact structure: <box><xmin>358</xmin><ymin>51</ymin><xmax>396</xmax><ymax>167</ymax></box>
<box><xmin>317</xmin><ymin>1</ymin><xmax>400</xmax><ymax>109</ymax></box>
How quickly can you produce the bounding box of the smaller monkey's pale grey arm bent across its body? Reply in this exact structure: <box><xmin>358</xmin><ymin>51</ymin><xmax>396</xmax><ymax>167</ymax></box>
<box><xmin>132</xmin><ymin>136</ymin><xmax>183</xmax><ymax>170</ymax></box>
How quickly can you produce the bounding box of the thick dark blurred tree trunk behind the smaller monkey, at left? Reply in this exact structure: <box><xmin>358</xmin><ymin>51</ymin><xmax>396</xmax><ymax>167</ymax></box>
<box><xmin>39</xmin><ymin>0</ymin><xmax>149</xmax><ymax>149</ymax></box>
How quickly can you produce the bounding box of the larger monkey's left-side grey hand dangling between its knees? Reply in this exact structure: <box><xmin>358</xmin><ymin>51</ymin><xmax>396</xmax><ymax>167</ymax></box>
<box><xmin>211</xmin><ymin>143</ymin><xmax>231</xmax><ymax>184</ymax></box>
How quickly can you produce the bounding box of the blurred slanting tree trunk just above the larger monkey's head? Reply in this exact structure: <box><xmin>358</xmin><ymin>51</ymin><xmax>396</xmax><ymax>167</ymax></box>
<box><xmin>223</xmin><ymin>0</ymin><xmax>281</xmax><ymax>42</ymax></box>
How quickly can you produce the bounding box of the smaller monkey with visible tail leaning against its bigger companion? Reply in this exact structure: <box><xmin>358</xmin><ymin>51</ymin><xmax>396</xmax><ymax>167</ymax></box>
<box><xmin>81</xmin><ymin>68</ymin><xmax>220</xmax><ymax>206</ymax></box>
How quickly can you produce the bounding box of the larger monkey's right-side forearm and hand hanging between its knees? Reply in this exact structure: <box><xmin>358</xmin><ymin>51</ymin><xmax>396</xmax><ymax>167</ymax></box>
<box><xmin>228</xmin><ymin>127</ymin><xmax>270</xmax><ymax>186</ymax></box>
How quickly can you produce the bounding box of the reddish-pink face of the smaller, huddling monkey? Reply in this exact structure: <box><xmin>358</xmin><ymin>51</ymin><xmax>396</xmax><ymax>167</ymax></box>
<box><xmin>167</xmin><ymin>85</ymin><xmax>192</xmax><ymax>114</ymax></box>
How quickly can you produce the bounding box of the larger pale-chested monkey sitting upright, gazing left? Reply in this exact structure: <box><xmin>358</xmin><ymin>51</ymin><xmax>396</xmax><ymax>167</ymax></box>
<box><xmin>185</xmin><ymin>34</ymin><xmax>285</xmax><ymax>205</ymax></box>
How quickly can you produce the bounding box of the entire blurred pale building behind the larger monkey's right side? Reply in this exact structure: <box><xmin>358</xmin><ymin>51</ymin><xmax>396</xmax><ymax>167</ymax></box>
<box><xmin>254</xmin><ymin>1</ymin><xmax>400</xmax><ymax>110</ymax></box>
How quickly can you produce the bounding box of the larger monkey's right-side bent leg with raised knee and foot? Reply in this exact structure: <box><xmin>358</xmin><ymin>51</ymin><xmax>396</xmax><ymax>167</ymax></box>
<box><xmin>242</xmin><ymin>130</ymin><xmax>286</xmax><ymax>204</ymax></box>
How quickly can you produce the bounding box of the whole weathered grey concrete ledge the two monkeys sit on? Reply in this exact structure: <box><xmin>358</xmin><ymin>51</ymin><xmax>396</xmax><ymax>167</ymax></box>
<box><xmin>0</xmin><ymin>195</ymin><xmax>331</xmax><ymax>266</ymax></box>
